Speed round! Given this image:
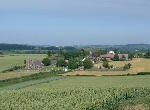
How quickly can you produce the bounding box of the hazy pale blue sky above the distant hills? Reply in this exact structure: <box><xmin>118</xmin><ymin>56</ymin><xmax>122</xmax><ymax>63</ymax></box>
<box><xmin>0</xmin><ymin>0</ymin><xmax>150</xmax><ymax>46</ymax></box>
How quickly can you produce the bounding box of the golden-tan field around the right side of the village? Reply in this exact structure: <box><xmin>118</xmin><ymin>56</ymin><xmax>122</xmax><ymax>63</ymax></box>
<box><xmin>65</xmin><ymin>58</ymin><xmax>150</xmax><ymax>76</ymax></box>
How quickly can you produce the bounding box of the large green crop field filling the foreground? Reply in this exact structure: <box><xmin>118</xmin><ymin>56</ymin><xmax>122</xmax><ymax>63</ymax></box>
<box><xmin>0</xmin><ymin>76</ymin><xmax>150</xmax><ymax>110</ymax></box>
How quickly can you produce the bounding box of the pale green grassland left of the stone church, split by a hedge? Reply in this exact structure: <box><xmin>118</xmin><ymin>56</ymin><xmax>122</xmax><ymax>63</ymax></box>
<box><xmin>0</xmin><ymin>54</ymin><xmax>46</xmax><ymax>80</ymax></box>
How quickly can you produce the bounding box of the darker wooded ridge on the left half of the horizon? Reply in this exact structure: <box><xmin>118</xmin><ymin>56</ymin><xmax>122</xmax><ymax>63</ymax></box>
<box><xmin>0</xmin><ymin>44</ymin><xmax>76</xmax><ymax>50</ymax></box>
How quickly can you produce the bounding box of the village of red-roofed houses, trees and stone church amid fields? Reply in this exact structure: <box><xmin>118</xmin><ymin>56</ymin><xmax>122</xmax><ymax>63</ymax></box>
<box><xmin>25</xmin><ymin>49</ymin><xmax>131</xmax><ymax>72</ymax></box>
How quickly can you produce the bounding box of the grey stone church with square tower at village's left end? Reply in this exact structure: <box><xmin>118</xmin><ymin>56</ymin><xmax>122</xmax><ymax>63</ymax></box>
<box><xmin>26</xmin><ymin>58</ymin><xmax>44</xmax><ymax>69</ymax></box>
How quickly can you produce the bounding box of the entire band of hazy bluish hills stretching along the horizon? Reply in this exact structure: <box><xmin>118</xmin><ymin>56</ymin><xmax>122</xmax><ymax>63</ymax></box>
<box><xmin>0</xmin><ymin>44</ymin><xmax>150</xmax><ymax>51</ymax></box>
